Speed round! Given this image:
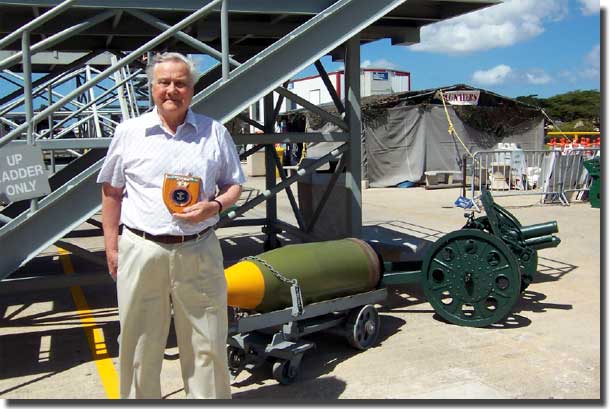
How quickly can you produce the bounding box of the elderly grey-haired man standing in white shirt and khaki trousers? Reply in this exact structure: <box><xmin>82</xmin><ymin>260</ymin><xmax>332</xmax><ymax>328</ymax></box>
<box><xmin>98</xmin><ymin>53</ymin><xmax>245</xmax><ymax>399</ymax></box>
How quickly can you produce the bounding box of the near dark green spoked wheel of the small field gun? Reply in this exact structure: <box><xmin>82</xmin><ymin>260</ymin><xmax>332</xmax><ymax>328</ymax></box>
<box><xmin>422</xmin><ymin>229</ymin><xmax>521</xmax><ymax>327</ymax></box>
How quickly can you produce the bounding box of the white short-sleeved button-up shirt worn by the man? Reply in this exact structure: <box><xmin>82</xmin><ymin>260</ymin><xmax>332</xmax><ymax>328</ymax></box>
<box><xmin>97</xmin><ymin>109</ymin><xmax>246</xmax><ymax>235</ymax></box>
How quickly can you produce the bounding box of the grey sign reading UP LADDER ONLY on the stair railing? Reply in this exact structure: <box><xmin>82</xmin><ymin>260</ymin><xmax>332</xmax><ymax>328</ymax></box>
<box><xmin>0</xmin><ymin>145</ymin><xmax>51</xmax><ymax>202</ymax></box>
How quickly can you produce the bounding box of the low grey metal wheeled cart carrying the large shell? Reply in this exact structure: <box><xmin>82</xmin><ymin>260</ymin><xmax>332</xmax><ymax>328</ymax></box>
<box><xmin>227</xmin><ymin>288</ymin><xmax>387</xmax><ymax>385</ymax></box>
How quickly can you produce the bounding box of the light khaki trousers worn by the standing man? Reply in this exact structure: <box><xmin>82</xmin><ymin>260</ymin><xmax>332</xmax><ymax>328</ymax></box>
<box><xmin>117</xmin><ymin>229</ymin><xmax>231</xmax><ymax>399</ymax></box>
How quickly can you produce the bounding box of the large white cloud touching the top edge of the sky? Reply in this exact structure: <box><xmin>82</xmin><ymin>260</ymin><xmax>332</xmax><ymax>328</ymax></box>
<box><xmin>411</xmin><ymin>0</ymin><xmax>568</xmax><ymax>54</ymax></box>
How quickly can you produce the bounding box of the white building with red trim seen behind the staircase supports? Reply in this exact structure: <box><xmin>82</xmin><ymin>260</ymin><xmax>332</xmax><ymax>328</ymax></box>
<box><xmin>249</xmin><ymin>67</ymin><xmax>411</xmax><ymax>133</ymax></box>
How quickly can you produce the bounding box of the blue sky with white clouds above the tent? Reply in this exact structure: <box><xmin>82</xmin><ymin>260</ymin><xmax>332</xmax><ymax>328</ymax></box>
<box><xmin>299</xmin><ymin>0</ymin><xmax>605</xmax><ymax>98</ymax></box>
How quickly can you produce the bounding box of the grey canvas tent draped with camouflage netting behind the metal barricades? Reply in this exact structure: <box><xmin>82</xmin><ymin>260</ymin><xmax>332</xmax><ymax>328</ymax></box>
<box><xmin>274</xmin><ymin>85</ymin><xmax>544</xmax><ymax>187</ymax></box>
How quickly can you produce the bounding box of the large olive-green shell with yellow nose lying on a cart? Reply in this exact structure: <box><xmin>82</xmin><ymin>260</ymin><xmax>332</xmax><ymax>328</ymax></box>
<box><xmin>225</xmin><ymin>238</ymin><xmax>381</xmax><ymax>312</ymax></box>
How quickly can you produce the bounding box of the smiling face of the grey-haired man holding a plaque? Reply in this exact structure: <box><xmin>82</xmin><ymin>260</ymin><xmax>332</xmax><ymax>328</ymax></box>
<box><xmin>152</xmin><ymin>61</ymin><xmax>193</xmax><ymax>117</ymax></box>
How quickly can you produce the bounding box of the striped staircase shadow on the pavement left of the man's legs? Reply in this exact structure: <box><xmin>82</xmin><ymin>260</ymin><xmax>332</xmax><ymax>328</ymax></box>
<box><xmin>0</xmin><ymin>289</ymin><xmax>119</xmax><ymax>396</ymax></box>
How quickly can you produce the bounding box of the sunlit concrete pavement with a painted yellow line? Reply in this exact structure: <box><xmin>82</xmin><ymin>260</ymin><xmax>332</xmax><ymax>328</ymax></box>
<box><xmin>0</xmin><ymin>178</ymin><xmax>601</xmax><ymax>403</ymax></box>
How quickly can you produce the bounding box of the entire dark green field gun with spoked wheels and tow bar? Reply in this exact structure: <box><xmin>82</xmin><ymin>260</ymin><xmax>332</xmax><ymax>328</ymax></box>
<box><xmin>382</xmin><ymin>190</ymin><xmax>561</xmax><ymax>327</ymax></box>
